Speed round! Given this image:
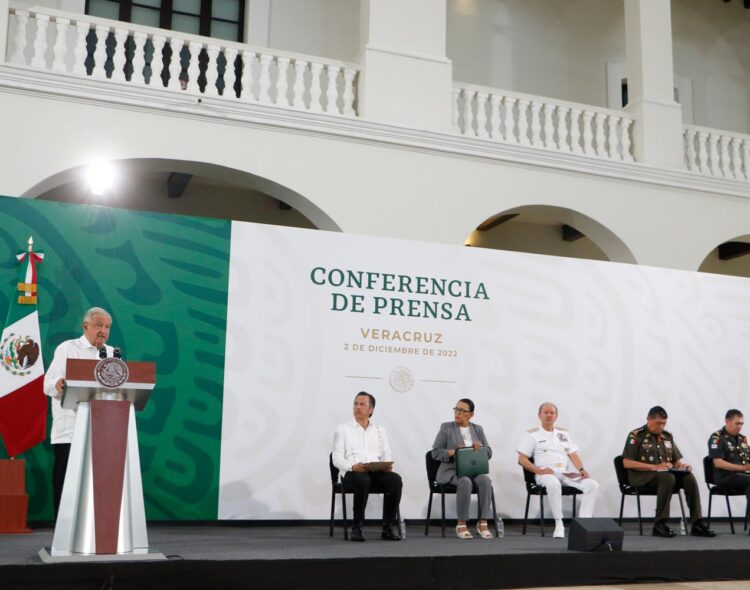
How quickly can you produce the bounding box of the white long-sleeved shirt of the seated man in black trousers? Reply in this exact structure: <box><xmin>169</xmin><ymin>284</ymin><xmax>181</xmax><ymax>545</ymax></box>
<box><xmin>333</xmin><ymin>418</ymin><xmax>393</xmax><ymax>473</ymax></box>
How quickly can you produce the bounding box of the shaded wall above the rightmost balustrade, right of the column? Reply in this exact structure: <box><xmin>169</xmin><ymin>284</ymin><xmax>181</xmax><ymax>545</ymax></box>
<box><xmin>672</xmin><ymin>0</ymin><xmax>750</xmax><ymax>133</ymax></box>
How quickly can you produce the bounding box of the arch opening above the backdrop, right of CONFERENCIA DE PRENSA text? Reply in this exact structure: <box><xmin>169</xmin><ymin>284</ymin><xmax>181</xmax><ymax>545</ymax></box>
<box><xmin>466</xmin><ymin>205</ymin><xmax>637</xmax><ymax>263</ymax></box>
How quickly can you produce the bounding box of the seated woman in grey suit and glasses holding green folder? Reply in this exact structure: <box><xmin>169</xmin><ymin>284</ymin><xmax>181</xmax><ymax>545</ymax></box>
<box><xmin>432</xmin><ymin>399</ymin><xmax>492</xmax><ymax>539</ymax></box>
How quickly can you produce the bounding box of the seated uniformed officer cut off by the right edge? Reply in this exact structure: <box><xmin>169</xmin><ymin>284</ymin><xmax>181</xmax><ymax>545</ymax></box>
<box><xmin>708</xmin><ymin>410</ymin><xmax>750</xmax><ymax>520</ymax></box>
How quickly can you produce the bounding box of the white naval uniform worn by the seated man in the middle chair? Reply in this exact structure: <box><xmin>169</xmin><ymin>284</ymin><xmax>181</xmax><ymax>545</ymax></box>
<box><xmin>516</xmin><ymin>427</ymin><xmax>599</xmax><ymax>520</ymax></box>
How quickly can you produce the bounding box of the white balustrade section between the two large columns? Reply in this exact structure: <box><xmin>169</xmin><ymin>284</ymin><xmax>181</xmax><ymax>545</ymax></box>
<box><xmin>452</xmin><ymin>84</ymin><xmax>633</xmax><ymax>162</ymax></box>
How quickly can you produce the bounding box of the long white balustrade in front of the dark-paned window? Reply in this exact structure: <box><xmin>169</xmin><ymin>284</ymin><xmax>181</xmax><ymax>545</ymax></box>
<box><xmin>3</xmin><ymin>6</ymin><xmax>359</xmax><ymax>117</ymax></box>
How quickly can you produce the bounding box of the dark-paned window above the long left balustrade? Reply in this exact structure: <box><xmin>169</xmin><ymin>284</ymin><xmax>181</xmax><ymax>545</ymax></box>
<box><xmin>86</xmin><ymin>0</ymin><xmax>245</xmax><ymax>41</ymax></box>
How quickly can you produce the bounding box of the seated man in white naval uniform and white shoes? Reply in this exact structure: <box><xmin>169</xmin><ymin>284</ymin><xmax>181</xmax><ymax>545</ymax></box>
<box><xmin>516</xmin><ymin>402</ymin><xmax>599</xmax><ymax>539</ymax></box>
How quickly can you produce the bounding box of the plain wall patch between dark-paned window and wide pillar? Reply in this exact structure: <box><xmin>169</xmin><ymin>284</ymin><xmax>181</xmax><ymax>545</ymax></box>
<box><xmin>266</xmin><ymin>0</ymin><xmax>360</xmax><ymax>61</ymax></box>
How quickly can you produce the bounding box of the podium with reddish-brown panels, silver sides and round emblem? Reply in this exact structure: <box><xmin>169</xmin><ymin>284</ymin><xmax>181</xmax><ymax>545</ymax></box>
<box><xmin>39</xmin><ymin>358</ymin><xmax>165</xmax><ymax>563</ymax></box>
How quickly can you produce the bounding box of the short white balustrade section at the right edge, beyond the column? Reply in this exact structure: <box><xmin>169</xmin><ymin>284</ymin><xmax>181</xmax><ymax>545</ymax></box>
<box><xmin>682</xmin><ymin>125</ymin><xmax>750</xmax><ymax>181</ymax></box>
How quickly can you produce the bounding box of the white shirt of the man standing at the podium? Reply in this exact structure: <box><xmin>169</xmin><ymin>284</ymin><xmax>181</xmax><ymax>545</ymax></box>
<box><xmin>44</xmin><ymin>336</ymin><xmax>114</xmax><ymax>445</ymax></box>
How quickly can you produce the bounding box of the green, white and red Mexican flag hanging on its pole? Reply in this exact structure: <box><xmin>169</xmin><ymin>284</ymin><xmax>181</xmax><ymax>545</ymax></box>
<box><xmin>0</xmin><ymin>238</ymin><xmax>47</xmax><ymax>457</ymax></box>
